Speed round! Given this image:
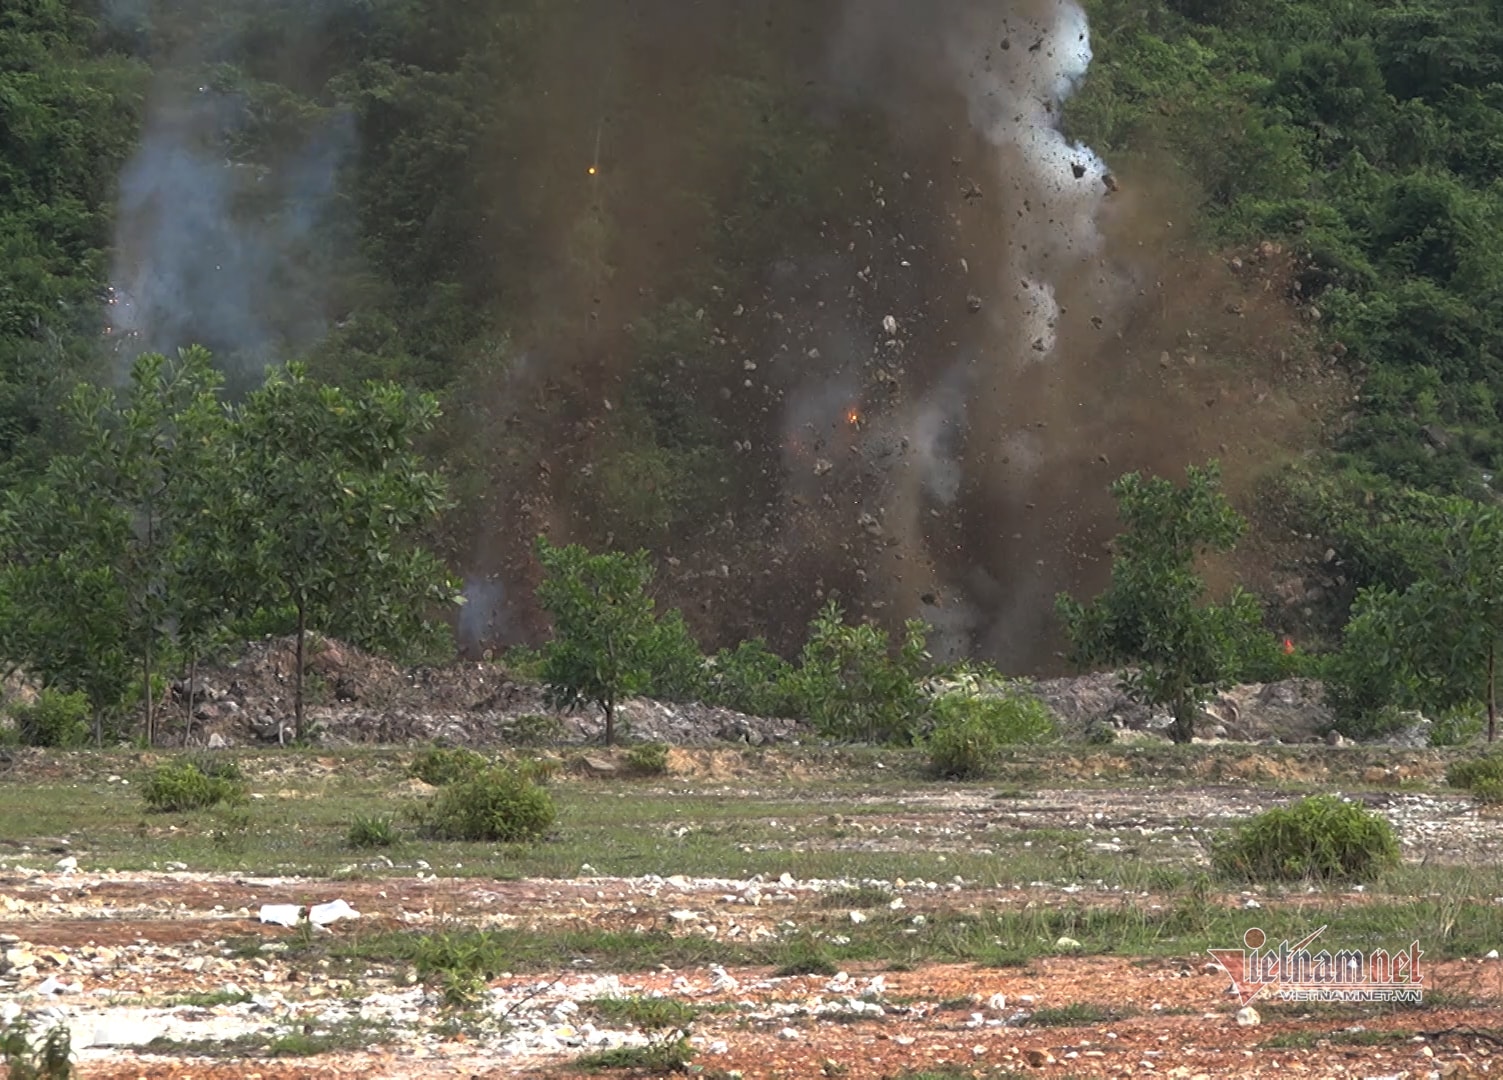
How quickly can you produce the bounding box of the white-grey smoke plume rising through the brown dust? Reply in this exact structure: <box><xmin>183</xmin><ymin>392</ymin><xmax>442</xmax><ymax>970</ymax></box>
<box><xmin>834</xmin><ymin>0</ymin><xmax>1121</xmax><ymax>656</ymax></box>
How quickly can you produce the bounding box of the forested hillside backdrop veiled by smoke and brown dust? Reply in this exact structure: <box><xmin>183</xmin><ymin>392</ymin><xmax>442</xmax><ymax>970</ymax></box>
<box><xmin>0</xmin><ymin>0</ymin><xmax>1503</xmax><ymax>705</ymax></box>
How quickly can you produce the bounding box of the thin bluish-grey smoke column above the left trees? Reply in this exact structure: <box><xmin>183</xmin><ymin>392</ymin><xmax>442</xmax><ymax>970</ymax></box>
<box><xmin>108</xmin><ymin>0</ymin><xmax>355</xmax><ymax>371</ymax></box>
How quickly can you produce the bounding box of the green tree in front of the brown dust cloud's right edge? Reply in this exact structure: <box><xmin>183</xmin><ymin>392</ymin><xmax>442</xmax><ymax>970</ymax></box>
<box><xmin>1055</xmin><ymin>461</ymin><xmax>1263</xmax><ymax>742</ymax></box>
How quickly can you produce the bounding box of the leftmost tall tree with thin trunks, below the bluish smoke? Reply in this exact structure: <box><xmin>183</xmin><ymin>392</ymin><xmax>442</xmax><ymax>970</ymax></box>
<box><xmin>6</xmin><ymin>348</ymin><xmax>230</xmax><ymax>744</ymax></box>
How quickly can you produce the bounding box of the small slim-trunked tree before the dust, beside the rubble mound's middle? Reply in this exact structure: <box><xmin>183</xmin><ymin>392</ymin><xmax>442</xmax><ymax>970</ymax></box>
<box><xmin>537</xmin><ymin>536</ymin><xmax>658</xmax><ymax>747</ymax></box>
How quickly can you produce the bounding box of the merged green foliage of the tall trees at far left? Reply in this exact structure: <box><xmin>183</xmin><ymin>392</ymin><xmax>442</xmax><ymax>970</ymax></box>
<box><xmin>0</xmin><ymin>348</ymin><xmax>457</xmax><ymax>738</ymax></box>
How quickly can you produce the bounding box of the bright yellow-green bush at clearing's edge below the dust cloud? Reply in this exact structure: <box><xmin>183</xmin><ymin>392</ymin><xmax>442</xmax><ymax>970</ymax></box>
<box><xmin>927</xmin><ymin>689</ymin><xmax>1054</xmax><ymax>780</ymax></box>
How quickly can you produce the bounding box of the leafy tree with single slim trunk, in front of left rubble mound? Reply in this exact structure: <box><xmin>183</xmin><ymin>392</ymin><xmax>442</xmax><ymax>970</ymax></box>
<box><xmin>224</xmin><ymin>365</ymin><xmax>460</xmax><ymax>738</ymax></box>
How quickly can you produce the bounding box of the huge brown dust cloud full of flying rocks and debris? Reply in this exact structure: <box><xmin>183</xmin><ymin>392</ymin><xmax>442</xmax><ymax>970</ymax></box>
<box><xmin>453</xmin><ymin>0</ymin><xmax>1328</xmax><ymax>673</ymax></box>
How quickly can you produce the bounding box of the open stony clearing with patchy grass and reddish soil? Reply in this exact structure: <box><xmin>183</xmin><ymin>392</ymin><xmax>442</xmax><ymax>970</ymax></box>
<box><xmin>0</xmin><ymin>744</ymin><xmax>1503</xmax><ymax>1080</ymax></box>
